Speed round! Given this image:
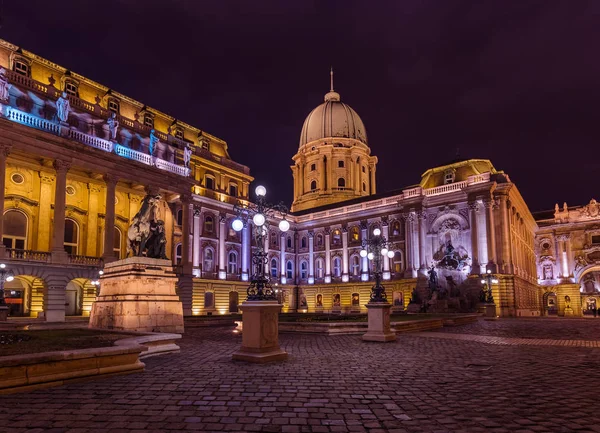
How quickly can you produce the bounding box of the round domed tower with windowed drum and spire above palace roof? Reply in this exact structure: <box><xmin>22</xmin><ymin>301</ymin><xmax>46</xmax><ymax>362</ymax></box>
<box><xmin>291</xmin><ymin>70</ymin><xmax>377</xmax><ymax>212</ymax></box>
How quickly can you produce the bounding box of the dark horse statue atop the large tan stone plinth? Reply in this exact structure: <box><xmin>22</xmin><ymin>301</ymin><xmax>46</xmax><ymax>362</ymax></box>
<box><xmin>127</xmin><ymin>194</ymin><xmax>166</xmax><ymax>259</ymax></box>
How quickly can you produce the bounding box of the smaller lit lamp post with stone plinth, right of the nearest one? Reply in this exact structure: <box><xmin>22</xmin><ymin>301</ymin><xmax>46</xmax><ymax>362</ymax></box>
<box><xmin>360</xmin><ymin>228</ymin><xmax>396</xmax><ymax>342</ymax></box>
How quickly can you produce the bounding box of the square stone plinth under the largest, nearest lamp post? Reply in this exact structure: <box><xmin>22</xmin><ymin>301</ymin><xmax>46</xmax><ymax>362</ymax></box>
<box><xmin>232</xmin><ymin>301</ymin><xmax>287</xmax><ymax>363</ymax></box>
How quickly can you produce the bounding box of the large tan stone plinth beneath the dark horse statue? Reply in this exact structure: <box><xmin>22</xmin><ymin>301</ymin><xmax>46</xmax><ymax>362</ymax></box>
<box><xmin>89</xmin><ymin>257</ymin><xmax>183</xmax><ymax>334</ymax></box>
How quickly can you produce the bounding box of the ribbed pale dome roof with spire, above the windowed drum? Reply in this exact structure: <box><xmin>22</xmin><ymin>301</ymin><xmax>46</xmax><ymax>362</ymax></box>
<box><xmin>300</xmin><ymin>73</ymin><xmax>367</xmax><ymax>146</ymax></box>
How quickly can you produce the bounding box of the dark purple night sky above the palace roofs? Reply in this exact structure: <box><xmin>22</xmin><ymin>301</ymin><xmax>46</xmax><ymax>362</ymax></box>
<box><xmin>0</xmin><ymin>0</ymin><xmax>600</xmax><ymax>211</ymax></box>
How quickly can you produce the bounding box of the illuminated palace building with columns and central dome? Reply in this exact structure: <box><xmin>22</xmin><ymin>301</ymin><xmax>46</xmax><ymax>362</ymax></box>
<box><xmin>0</xmin><ymin>37</ymin><xmax>600</xmax><ymax>321</ymax></box>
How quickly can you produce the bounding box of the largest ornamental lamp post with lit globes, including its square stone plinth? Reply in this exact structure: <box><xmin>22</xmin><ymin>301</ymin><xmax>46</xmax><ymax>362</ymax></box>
<box><xmin>231</xmin><ymin>185</ymin><xmax>290</xmax><ymax>363</ymax></box>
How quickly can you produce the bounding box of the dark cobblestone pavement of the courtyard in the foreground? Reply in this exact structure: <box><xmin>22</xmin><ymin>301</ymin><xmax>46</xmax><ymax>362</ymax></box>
<box><xmin>0</xmin><ymin>319</ymin><xmax>600</xmax><ymax>433</ymax></box>
